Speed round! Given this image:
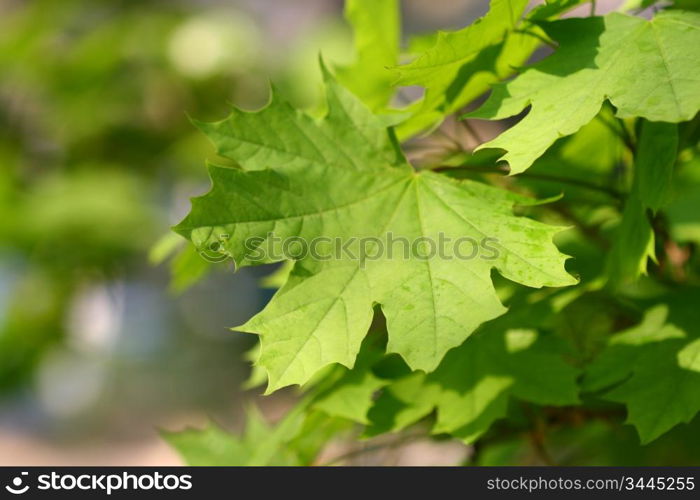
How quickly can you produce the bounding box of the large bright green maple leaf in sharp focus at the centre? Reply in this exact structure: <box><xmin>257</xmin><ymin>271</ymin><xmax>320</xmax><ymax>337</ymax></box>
<box><xmin>176</xmin><ymin>67</ymin><xmax>576</xmax><ymax>391</ymax></box>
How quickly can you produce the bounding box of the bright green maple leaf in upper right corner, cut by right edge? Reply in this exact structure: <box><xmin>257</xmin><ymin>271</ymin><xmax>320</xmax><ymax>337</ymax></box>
<box><xmin>467</xmin><ymin>10</ymin><xmax>700</xmax><ymax>173</ymax></box>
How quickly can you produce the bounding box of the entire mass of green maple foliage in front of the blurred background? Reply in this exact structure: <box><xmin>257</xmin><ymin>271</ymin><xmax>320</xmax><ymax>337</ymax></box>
<box><xmin>170</xmin><ymin>0</ymin><xmax>700</xmax><ymax>465</ymax></box>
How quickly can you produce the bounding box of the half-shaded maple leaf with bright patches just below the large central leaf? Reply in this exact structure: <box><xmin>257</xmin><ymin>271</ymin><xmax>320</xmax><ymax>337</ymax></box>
<box><xmin>367</xmin><ymin>325</ymin><xmax>578</xmax><ymax>442</ymax></box>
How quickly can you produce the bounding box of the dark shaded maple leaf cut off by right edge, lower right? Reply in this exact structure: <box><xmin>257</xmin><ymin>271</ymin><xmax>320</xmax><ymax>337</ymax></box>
<box><xmin>583</xmin><ymin>292</ymin><xmax>700</xmax><ymax>443</ymax></box>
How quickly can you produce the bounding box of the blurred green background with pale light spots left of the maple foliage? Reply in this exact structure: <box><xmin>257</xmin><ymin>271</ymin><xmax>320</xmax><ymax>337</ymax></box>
<box><xmin>0</xmin><ymin>0</ymin><xmax>628</xmax><ymax>465</ymax></box>
